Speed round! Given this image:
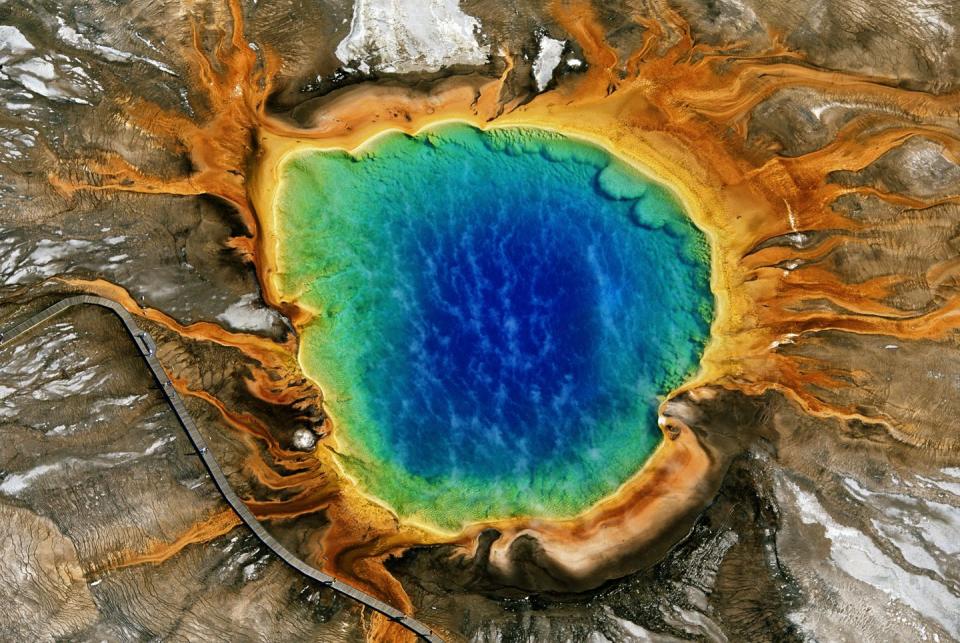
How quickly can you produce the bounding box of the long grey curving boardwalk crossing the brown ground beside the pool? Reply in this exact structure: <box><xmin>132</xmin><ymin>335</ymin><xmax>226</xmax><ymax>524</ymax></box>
<box><xmin>0</xmin><ymin>295</ymin><xmax>443</xmax><ymax>643</ymax></box>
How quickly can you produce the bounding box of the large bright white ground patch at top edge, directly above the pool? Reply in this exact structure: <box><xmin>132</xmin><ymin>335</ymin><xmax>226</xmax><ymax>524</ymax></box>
<box><xmin>336</xmin><ymin>0</ymin><xmax>490</xmax><ymax>73</ymax></box>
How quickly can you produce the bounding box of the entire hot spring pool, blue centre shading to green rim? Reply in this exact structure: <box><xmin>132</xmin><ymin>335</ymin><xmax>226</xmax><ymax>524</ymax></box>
<box><xmin>277</xmin><ymin>125</ymin><xmax>712</xmax><ymax>529</ymax></box>
